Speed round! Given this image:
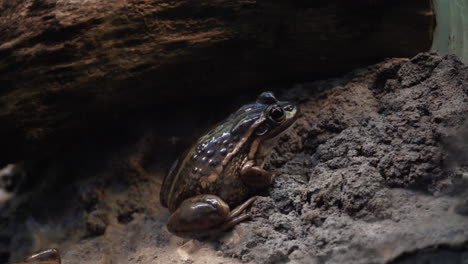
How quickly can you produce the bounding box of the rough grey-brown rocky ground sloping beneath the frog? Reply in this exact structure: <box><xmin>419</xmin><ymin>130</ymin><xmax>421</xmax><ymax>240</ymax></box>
<box><xmin>0</xmin><ymin>53</ymin><xmax>468</xmax><ymax>264</ymax></box>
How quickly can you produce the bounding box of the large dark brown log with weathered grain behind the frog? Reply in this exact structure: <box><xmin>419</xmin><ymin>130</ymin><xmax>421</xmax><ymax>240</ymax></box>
<box><xmin>0</xmin><ymin>0</ymin><xmax>434</xmax><ymax>165</ymax></box>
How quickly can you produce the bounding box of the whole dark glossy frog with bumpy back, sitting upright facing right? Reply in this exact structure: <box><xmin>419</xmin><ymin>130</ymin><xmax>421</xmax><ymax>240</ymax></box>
<box><xmin>161</xmin><ymin>92</ymin><xmax>298</xmax><ymax>237</ymax></box>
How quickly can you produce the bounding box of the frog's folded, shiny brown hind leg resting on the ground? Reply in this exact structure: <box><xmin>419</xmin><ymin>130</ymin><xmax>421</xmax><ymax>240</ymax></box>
<box><xmin>167</xmin><ymin>194</ymin><xmax>256</xmax><ymax>237</ymax></box>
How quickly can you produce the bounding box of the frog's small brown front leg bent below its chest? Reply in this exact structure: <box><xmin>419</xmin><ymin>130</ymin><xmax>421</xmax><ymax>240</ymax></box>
<box><xmin>241</xmin><ymin>161</ymin><xmax>274</xmax><ymax>189</ymax></box>
